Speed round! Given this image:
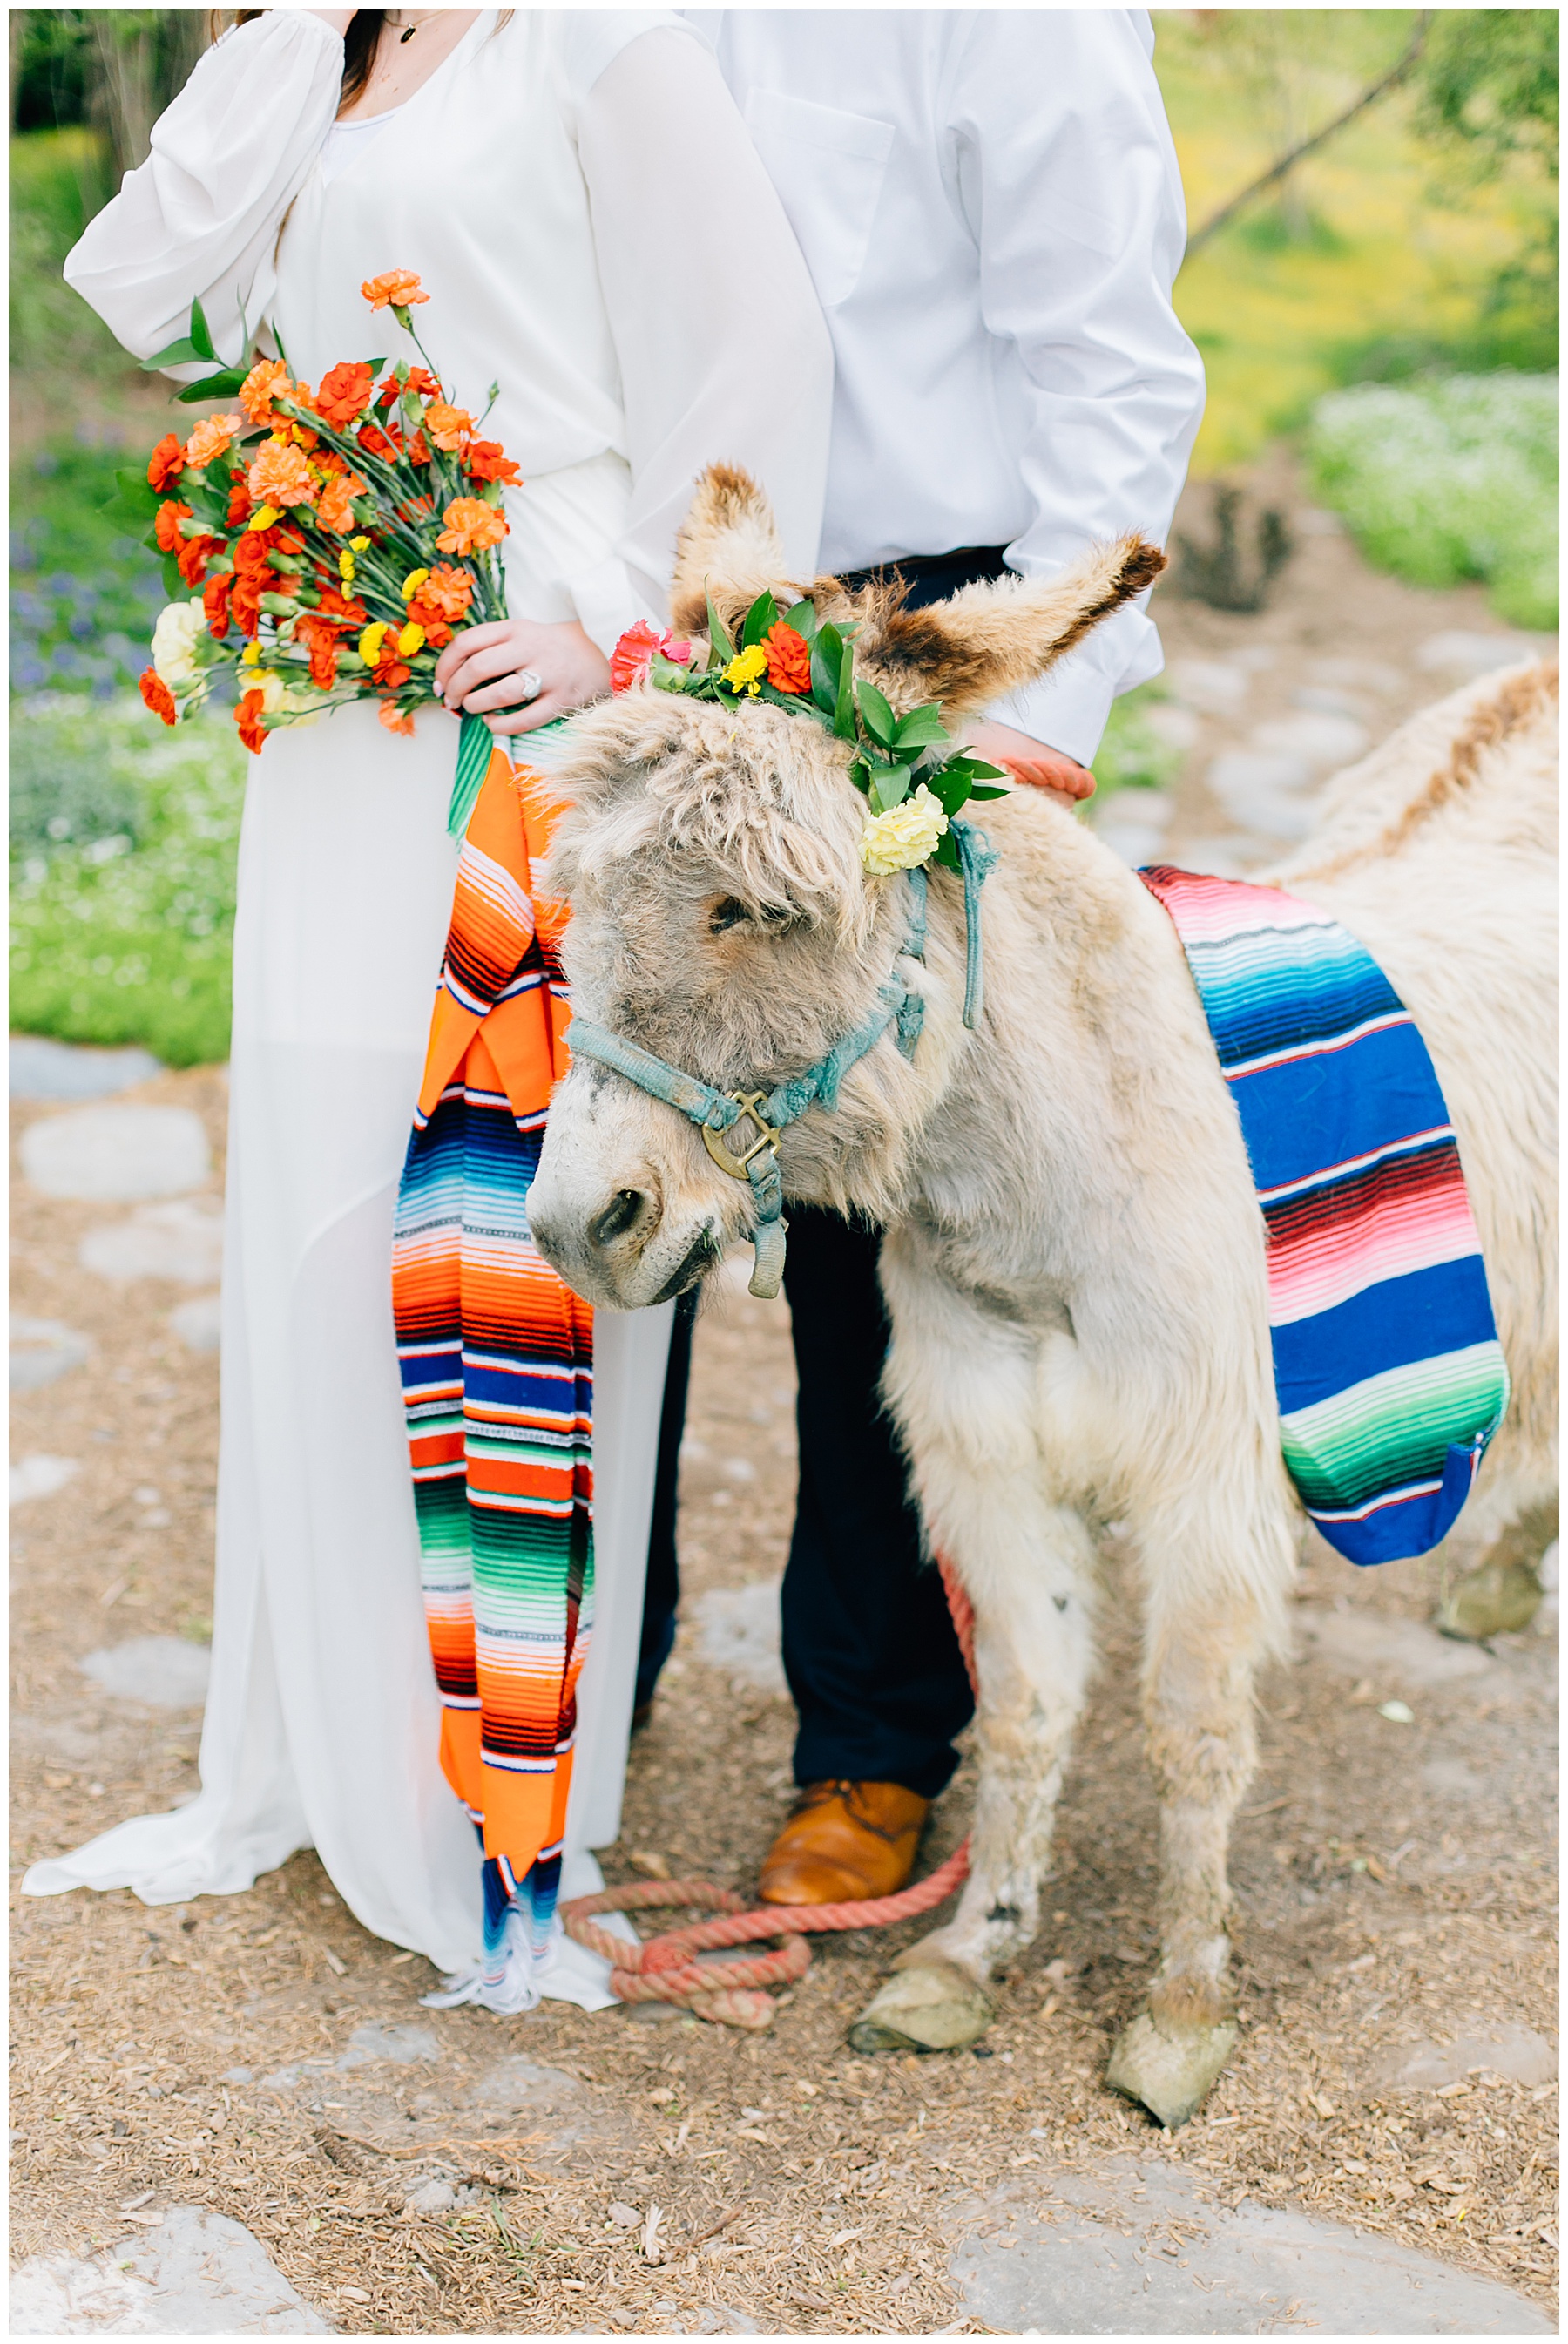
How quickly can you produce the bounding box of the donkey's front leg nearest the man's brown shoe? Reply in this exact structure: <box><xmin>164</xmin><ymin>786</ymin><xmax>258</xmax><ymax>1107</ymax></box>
<box><xmin>851</xmin><ymin>1254</ymin><xmax>1092</xmax><ymax>2049</ymax></box>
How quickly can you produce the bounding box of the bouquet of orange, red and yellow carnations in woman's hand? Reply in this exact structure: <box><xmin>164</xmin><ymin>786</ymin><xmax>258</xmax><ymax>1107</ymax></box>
<box><xmin>115</xmin><ymin>269</ymin><xmax>520</xmax><ymax>830</ymax></box>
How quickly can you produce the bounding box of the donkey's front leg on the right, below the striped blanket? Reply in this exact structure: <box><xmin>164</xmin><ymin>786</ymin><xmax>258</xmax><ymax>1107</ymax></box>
<box><xmin>1106</xmin><ymin>1494</ymin><xmax>1292</xmax><ymax>2131</ymax></box>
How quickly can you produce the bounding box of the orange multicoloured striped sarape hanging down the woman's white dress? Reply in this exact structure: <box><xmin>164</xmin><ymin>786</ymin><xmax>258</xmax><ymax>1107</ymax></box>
<box><xmin>391</xmin><ymin>736</ymin><xmax>593</xmax><ymax>2011</ymax></box>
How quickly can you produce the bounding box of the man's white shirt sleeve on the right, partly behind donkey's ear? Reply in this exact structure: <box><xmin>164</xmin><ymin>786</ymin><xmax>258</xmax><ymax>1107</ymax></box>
<box><xmin>947</xmin><ymin>10</ymin><xmax>1205</xmax><ymax>764</ymax></box>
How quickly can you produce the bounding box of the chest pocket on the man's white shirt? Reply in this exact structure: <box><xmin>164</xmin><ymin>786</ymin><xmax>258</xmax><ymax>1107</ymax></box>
<box><xmin>746</xmin><ymin>89</ymin><xmax>893</xmax><ymax>309</ymax></box>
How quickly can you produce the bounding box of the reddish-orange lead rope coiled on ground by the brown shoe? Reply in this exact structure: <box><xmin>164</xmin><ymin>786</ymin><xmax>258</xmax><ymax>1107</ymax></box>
<box><xmin>560</xmin><ymin>1556</ymin><xmax>980</xmax><ymax>2028</ymax></box>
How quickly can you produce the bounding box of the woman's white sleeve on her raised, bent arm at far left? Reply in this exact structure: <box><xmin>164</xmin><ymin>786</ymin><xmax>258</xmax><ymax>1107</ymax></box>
<box><xmin>65</xmin><ymin>7</ymin><xmax>342</xmax><ymax>366</ymax></box>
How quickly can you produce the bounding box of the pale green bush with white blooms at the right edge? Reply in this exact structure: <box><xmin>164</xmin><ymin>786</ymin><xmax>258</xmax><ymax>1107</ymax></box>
<box><xmin>1308</xmin><ymin>373</ymin><xmax>1557</xmax><ymax>628</ymax></box>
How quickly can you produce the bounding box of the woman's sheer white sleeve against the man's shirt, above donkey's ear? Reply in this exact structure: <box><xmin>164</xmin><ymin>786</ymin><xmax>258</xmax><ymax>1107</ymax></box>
<box><xmin>564</xmin><ymin>24</ymin><xmax>832</xmax><ymax>633</ymax></box>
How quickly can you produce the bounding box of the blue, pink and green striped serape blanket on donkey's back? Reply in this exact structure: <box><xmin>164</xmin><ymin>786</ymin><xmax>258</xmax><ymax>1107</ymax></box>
<box><xmin>1139</xmin><ymin>865</ymin><xmax>1507</xmax><ymax>1563</ymax></box>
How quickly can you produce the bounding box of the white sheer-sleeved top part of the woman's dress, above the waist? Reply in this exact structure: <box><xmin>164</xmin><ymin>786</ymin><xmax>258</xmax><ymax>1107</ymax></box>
<box><xmin>65</xmin><ymin>10</ymin><xmax>832</xmax><ymax>649</ymax></box>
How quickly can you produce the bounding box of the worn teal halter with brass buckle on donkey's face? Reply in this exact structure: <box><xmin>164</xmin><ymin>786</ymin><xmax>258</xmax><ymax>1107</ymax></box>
<box><xmin>567</xmin><ymin>821</ymin><xmax>996</xmax><ymax>1301</ymax></box>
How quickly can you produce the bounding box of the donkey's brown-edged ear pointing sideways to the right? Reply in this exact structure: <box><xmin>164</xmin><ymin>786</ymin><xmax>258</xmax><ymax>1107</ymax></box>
<box><xmin>855</xmin><ymin>532</ymin><xmax>1165</xmax><ymax>715</ymax></box>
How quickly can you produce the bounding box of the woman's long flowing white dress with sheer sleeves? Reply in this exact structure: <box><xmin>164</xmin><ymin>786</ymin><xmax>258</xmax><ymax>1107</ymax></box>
<box><xmin>24</xmin><ymin>10</ymin><xmax>832</xmax><ymax>2007</ymax></box>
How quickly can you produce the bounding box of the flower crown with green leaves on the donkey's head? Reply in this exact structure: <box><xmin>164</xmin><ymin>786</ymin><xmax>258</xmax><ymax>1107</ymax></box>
<box><xmin>610</xmin><ymin>591</ymin><xmax>1008</xmax><ymax>877</ymax></box>
